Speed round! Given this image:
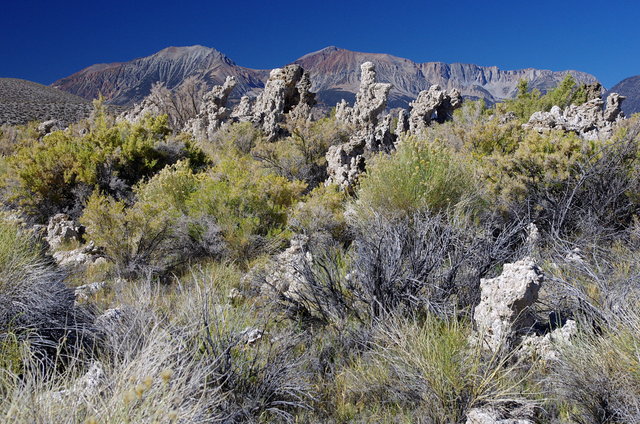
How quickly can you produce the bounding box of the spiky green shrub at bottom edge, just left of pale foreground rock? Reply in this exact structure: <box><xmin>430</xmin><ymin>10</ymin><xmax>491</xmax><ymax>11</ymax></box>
<box><xmin>336</xmin><ymin>316</ymin><xmax>530</xmax><ymax>424</ymax></box>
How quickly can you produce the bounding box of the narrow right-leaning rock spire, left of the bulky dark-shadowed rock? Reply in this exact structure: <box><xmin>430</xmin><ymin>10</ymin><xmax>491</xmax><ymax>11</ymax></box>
<box><xmin>185</xmin><ymin>77</ymin><xmax>237</xmax><ymax>139</ymax></box>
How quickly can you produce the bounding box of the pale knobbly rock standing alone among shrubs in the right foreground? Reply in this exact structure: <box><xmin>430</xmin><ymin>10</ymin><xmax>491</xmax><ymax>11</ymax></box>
<box><xmin>473</xmin><ymin>258</ymin><xmax>543</xmax><ymax>352</ymax></box>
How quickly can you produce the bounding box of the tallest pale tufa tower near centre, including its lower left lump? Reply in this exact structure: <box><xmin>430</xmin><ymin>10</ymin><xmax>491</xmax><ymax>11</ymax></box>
<box><xmin>326</xmin><ymin>62</ymin><xmax>396</xmax><ymax>191</ymax></box>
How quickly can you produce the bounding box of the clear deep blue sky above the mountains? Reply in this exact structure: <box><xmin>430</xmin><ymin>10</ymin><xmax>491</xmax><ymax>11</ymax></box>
<box><xmin>0</xmin><ymin>0</ymin><xmax>640</xmax><ymax>87</ymax></box>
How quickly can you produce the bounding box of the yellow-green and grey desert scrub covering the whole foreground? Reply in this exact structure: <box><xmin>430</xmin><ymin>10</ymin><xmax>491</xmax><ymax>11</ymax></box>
<box><xmin>0</xmin><ymin>80</ymin><xmax>640</xmax><ymax>423</ymax></box>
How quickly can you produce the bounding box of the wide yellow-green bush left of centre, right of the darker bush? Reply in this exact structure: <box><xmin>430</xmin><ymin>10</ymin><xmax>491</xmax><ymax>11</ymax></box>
<box><xmin>81</xmin><ymin>154</ymin><xmax>305</xmax><ymax>275</ymax></box>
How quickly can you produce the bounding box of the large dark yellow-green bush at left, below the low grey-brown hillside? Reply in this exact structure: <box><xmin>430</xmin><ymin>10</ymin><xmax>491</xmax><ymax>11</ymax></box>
<box><xmin>8</xmin><ymin>104</ymin><xmax>203</xmax><ymax>219</ymax></box>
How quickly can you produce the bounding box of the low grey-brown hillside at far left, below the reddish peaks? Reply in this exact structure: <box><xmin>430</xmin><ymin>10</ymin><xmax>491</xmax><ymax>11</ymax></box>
<box><xmin>0</xmin><ymin>78</ymin><xmax>92</xmax><ymax>125</ymax></box>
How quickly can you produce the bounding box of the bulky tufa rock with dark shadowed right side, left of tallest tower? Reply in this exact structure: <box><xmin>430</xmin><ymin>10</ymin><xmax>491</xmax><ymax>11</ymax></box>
<box><xmin>252</xmin><ymin>65</ymin><xmax>315</xmax><ymax>141</ymax></box>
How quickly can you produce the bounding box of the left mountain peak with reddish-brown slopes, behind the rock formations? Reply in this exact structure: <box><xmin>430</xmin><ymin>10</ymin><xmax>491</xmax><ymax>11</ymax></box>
<box><xmin>52</xmin><ymin>46</ymin><xmax>269</xmax><ymax>105</ymax></box>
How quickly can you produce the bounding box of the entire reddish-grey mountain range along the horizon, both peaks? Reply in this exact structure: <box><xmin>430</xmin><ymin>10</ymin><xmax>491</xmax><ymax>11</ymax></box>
<box><xmin>53</xmin><ymin>46</ymin><xmax>597</xmax><ymax>107</ymax></box>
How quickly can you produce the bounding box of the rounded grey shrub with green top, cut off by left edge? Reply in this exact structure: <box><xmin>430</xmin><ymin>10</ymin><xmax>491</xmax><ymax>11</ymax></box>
<box><xmin>0</xmin><ymin>216</ymin><xmax>96</xmax><ymax>372</ymax></box>
